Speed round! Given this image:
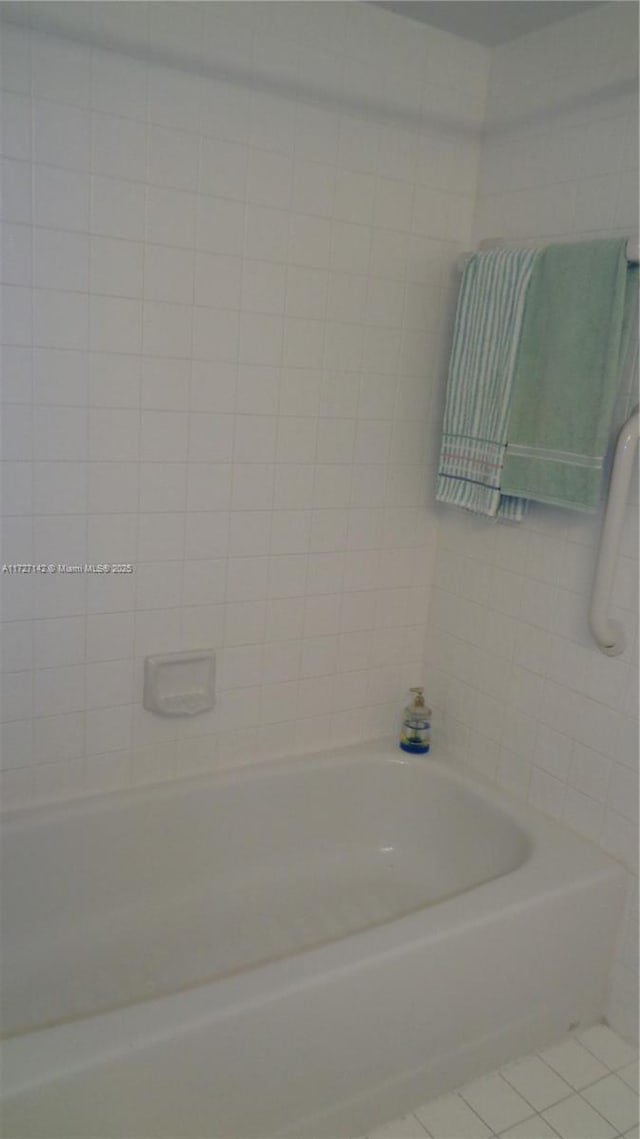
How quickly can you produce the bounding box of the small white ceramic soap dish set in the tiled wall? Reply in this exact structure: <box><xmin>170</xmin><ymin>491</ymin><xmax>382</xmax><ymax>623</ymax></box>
<box><xmin>142</xmin><ymin>649</ymin><xmax>215</xmax><ymax>715</ymax></box>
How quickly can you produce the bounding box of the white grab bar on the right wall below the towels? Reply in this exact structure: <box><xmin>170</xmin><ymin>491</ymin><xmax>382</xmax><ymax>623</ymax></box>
<box><xmin>589</xmin><ymin>410</ymin><xmax>640</xmax><ymax>656</ymax></box>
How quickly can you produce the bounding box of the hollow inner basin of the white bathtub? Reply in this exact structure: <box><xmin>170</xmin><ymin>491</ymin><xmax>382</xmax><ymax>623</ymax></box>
<box><xmin>1</xmin><ymin>751</ymin><xmax>530</xmax><ymax>1035</ymax></box>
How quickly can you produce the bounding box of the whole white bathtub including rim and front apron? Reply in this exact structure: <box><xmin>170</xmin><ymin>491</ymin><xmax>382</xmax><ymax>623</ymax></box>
<box><xmin>1</xmin><ymin>744</ymin><xmax>624</xmax><ymax>1139</ymax></box>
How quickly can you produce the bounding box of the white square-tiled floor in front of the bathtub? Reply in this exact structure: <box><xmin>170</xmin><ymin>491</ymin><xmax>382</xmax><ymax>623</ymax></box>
<box><xmin>368</xmin><ymin>1024</ymin><xmax>639</xmax><ymax>1139</ymax></box>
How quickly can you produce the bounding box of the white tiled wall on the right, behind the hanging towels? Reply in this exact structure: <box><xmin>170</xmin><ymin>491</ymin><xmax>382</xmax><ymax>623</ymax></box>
<box><xmin>426</xmin><ymin>3</ymin><xmax>638</xmax><ymax>1036</ymax></box>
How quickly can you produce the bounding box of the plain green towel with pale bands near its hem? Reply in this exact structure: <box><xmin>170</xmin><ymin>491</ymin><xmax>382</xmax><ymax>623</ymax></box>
<box><xmin>501</xmin><ymin>239</ymin><xmax>638</xmax><ymax>510</ymax></box>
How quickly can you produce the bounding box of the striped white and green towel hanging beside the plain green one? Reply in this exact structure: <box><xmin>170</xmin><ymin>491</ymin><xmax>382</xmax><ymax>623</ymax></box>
<box><xmin>436</xmin><ymin>249</ymin><xmax>538</xmax><ymax>522</ymax></box>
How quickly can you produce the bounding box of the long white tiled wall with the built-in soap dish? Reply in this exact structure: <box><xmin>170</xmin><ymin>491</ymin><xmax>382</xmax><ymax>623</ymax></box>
<box><xmin>0</xmin><ymin>3</ymin><xmax>489</xmax><ymax>805</ymax></box>
